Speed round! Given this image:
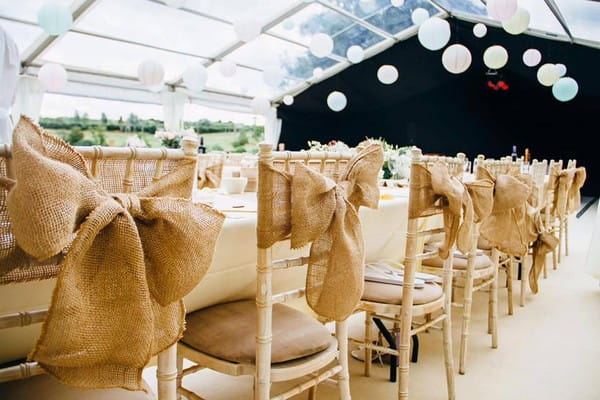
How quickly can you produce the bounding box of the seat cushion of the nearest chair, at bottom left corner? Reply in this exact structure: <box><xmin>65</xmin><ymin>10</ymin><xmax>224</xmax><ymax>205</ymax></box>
<box><xmin>0</xmin><ymin>375</ymin><xmax>155</xmax><ymax>400</ymax></box>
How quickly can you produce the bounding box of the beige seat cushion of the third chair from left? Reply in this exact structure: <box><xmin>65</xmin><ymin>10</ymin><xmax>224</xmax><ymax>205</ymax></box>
<box><xmin>362</xmin><ymin>281</ymin><xmax>444</xmax><ymax>305</ymax></box>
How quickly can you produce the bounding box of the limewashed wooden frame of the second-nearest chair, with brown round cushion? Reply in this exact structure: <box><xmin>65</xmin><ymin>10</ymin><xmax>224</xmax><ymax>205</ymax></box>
<box><xmin>178</xmin><ymin>143</ymin><xmax>352</xmax><ymax>400</ymax></box>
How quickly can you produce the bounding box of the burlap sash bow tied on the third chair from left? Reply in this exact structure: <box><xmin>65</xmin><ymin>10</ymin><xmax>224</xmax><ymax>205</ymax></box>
<box><xmin>408</xmin><ymin>162</ymin><xmax>493</xmax><ymax>260</ymax></box>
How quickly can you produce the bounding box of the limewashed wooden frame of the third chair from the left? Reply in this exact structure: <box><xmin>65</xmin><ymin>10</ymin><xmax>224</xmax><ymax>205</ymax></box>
<box><xmin>353</xmin><ymin>149</ymin><xmax>464</xmax><ymax>399</ymax></box>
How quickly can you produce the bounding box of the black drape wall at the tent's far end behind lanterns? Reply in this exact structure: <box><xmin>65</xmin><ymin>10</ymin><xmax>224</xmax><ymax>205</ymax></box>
<box><xmin>278</xmin><ymin>20</ymin><xmax>600</xmax><ymax>195</ymax></box>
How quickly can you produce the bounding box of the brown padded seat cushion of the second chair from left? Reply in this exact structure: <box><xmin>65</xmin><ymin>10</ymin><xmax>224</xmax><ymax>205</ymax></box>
<box><xmin>181</xmin><ymin>300</ymin><xmax>331</xmax><ymax>364</ymax></box>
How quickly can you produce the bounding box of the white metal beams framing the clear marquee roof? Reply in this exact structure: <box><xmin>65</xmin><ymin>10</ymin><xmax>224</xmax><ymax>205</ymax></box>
<box><xmin>0</xmin><ymin>0</ymin><xmax>600</xmax><ymax>112</ymax></box>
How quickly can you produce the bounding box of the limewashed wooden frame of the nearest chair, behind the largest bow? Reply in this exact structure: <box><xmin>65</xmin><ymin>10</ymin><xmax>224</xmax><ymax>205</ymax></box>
<box><xmin>0</xmin><ymin>138</ymin><xmax>198</xmax><ymax>400</ymax></box>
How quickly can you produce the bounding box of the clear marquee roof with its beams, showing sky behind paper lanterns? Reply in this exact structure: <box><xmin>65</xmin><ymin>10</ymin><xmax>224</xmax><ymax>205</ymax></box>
<box><xmin>0</xmin><ymin>0</ymin><xmax>600</xmax><ymax>111</ymax></box>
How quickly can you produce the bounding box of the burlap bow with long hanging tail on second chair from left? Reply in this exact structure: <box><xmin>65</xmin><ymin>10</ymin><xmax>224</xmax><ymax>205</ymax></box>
<box><xmin>258</xmin><ymin>144</ymin><xmax>383</xmax><ymax>321</ymax></box>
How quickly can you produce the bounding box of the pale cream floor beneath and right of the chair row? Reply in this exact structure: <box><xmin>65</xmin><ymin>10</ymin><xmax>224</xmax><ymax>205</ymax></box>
<box><xmin>144</xmin><ymin>206</ymin><xmax>600</xmax><ymax>400</ymax></box>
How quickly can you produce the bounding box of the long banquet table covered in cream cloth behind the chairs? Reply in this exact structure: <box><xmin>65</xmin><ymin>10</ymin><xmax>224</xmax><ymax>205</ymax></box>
<box><xmin>0</xmin><ymin>188</ymin><xmax>408</xmax><ymax>363</ymax></box>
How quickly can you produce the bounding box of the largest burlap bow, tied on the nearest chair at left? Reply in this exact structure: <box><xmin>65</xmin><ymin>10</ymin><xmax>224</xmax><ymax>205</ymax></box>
<box><xmin>4</xmin><ymin>119</ymin><xmax>224</xmax><ymax>390</ymax></box>
